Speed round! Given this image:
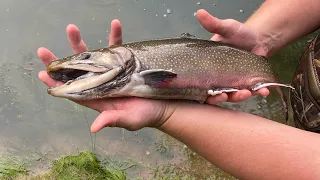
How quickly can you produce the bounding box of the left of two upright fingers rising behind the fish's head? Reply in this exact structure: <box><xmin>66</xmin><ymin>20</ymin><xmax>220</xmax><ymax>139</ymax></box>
<box><xmin>66</xmin><ymin>24</ymin><xmax>88</xmax><ymax>54</ymax></box>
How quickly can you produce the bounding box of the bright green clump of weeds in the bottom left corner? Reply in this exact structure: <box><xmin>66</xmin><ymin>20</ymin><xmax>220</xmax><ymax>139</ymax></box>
<box><xmin>0</xmin><ymin>152</ymin><xmax>126</xmax><ymax>180</ymax></box>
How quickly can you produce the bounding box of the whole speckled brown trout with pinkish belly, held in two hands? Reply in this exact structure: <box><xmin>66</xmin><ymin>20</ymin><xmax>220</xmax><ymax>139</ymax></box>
<box><xmin>47</xmin><ymin>33</ymin><xmax>293</xmax><ymax>115</ymax></box>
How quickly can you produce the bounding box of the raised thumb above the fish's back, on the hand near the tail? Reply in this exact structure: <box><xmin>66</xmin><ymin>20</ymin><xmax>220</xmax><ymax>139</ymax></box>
<box><xmin>196</xmin><ymin>9</ymin><xmax>241</xmax><ymax>37</ymax></box>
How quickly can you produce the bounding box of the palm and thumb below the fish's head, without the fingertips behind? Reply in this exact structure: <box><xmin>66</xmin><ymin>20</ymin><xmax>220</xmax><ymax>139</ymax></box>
<box><xmin>80</xmin><ymin>97</ymin><xmax>167</xmax><ymax>132</ymax></box>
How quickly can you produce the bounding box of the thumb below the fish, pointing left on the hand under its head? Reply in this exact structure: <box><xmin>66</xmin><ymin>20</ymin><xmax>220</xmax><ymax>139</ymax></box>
<box><xmin>90</xmin><ymin>110</ymin><xmax>140</xmax><ymax>133</ymax></box>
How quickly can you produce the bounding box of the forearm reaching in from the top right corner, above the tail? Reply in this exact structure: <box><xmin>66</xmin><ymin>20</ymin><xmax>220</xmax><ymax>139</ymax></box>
<box><xmin>245</xmin><ymin>0</ymin><xmax>320</xmax><ymax>56</ymax></box>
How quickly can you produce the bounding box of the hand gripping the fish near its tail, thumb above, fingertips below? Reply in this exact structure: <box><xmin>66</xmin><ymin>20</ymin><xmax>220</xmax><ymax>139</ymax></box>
<box><xmin>196</xmin><ymin>9</ymin><xmax>270</xmax><ymax>104</ymax></box>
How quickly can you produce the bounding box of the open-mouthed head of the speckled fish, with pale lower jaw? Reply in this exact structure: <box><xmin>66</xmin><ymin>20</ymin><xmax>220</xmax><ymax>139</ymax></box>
<box><xmin>47</xmin><ymin>47</ymin><xmax>135</xmax><ymax>100</ymax></box>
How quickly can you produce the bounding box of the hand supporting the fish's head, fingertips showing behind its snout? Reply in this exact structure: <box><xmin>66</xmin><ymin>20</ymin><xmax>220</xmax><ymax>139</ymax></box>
<box><xmin>37</xmin><ymin>20</ymin><xmax>175</xmax><ymax>132</ymax></box>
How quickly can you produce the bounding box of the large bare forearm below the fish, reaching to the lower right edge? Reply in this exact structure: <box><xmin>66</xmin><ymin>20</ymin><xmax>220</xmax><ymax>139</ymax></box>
<box><xmin>159</xmin><ymin>104</ymin><xmax>320</xmax><ymax>179</ymax></box>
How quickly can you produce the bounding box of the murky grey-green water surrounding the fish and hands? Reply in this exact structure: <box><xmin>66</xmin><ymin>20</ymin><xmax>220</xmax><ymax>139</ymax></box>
<box><xmin>0</xmin><ymin>0</ymin><xmax>316</xmax><ymax>179</ymax></box>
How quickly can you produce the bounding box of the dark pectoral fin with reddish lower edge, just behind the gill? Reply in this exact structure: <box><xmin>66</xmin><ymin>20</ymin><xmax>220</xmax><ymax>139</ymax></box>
<box><xmin>140</xmin><ymin>69</ymin><xmax>177</xmax><ymax>87</ymax></box>
